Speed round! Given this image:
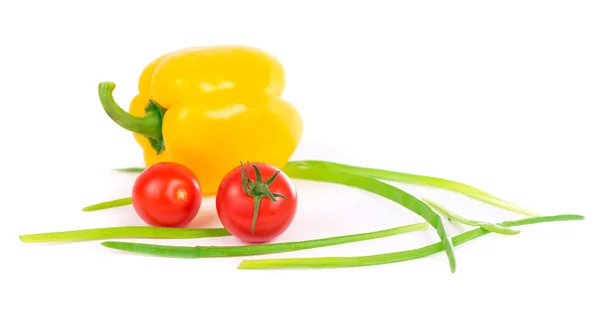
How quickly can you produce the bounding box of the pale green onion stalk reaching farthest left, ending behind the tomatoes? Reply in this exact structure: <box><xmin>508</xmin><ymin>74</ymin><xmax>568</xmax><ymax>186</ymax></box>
<box><xmin>19</xmin><ymin>226</ymin><xmax>231</xmax><ymax>243</ymax></box>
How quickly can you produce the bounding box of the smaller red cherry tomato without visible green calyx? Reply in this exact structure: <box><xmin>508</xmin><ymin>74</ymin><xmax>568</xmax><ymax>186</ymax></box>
<box><xmin>131</xmin><ymin>162</ymin><xmax>202</xmax><ymax>227</ymax></box>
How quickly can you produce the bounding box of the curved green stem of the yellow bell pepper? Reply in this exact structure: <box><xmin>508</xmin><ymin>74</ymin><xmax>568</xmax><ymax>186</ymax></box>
<box><xmin>98</xmin><ymin>82</ymin><xmax>162</xmax><ymax>140</ymax></box>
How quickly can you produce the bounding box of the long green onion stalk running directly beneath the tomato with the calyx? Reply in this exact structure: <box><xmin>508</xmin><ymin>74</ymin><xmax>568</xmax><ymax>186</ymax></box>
<box><xmin>102</xmin><ymin>223</ymin><xmax>429</xmax><ymax>258</ymax></box>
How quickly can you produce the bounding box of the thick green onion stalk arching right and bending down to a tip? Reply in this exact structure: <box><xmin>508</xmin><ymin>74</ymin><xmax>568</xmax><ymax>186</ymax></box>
<box><xmin>283</xmin><ymin>166</ymin><xmax>456</xmax><ymax>272</ymax></box>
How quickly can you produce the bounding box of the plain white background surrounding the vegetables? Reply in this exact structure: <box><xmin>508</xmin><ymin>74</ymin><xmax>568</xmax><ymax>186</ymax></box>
<box><xmin>0</xmin><ymin>0</ymin><xmax>600</xmax><ymax>309</ymax></box>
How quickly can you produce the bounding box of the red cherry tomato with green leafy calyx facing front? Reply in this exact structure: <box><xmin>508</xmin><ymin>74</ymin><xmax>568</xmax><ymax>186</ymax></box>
<box><xmin>216</xmin><ymin>163</ymin><xmax>297</xmax><ymax>243</ymax></box>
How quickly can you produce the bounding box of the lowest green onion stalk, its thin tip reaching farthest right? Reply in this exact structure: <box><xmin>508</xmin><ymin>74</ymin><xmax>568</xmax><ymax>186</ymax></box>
<box><xmin>238</xmin><ymin>214</ymin><xmax>584</xmax><ymax>269</ymax></box>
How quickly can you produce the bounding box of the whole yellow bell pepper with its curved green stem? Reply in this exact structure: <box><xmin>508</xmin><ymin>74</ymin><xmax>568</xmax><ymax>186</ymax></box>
<box><xmin>98</xmin><ymin>46</ymin><xmax>303</xmax><ymax>195</ymax></box>
